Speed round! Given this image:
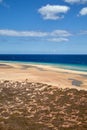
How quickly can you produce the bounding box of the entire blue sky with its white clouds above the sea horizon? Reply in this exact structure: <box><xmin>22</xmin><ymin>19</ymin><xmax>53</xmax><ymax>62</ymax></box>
<box><xmin>0</xmin><ymin>0</ymin><xmax>87</xmax><ymax>54</ymax></box>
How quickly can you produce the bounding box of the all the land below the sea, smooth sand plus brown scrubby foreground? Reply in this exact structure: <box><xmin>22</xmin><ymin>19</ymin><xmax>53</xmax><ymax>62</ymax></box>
<box><xmin>0</xmin><ymin>62</ymin><xmax>87</xmax><ymax>130</ymax></box>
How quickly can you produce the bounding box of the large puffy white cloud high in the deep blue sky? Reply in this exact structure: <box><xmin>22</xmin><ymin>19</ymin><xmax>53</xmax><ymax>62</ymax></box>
<box><xmin>38</xmin><ymin>4</ymin><xmax>70</xmax><ymax>20</ymax></box>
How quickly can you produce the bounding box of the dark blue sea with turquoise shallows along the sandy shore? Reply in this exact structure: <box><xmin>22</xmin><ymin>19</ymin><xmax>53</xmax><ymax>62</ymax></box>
<box><xmin>0</xmin><ymin>54</ymin><xmax>87</xmax><ymax>72</ymax></box>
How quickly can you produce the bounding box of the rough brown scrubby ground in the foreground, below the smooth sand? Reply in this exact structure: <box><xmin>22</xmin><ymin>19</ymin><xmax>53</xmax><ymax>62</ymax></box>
<box><xmin>0</xmin><ymin>80</ymin><xmax>87</xmax><ymax>130</ymax></box>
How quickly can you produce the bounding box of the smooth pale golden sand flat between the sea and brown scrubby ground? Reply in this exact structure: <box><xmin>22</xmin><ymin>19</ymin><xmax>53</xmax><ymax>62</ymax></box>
<box><xmin>0</xmin><ymin>62</ymin><xmax>87</xmax><ymax>89</ymax></box>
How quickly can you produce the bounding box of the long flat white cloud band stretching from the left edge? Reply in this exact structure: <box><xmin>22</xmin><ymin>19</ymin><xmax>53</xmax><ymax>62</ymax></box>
<box><xmin>0</xmin><ymin>29</ymin><xmax>72</xmax><ymax>37</ymax></box>
